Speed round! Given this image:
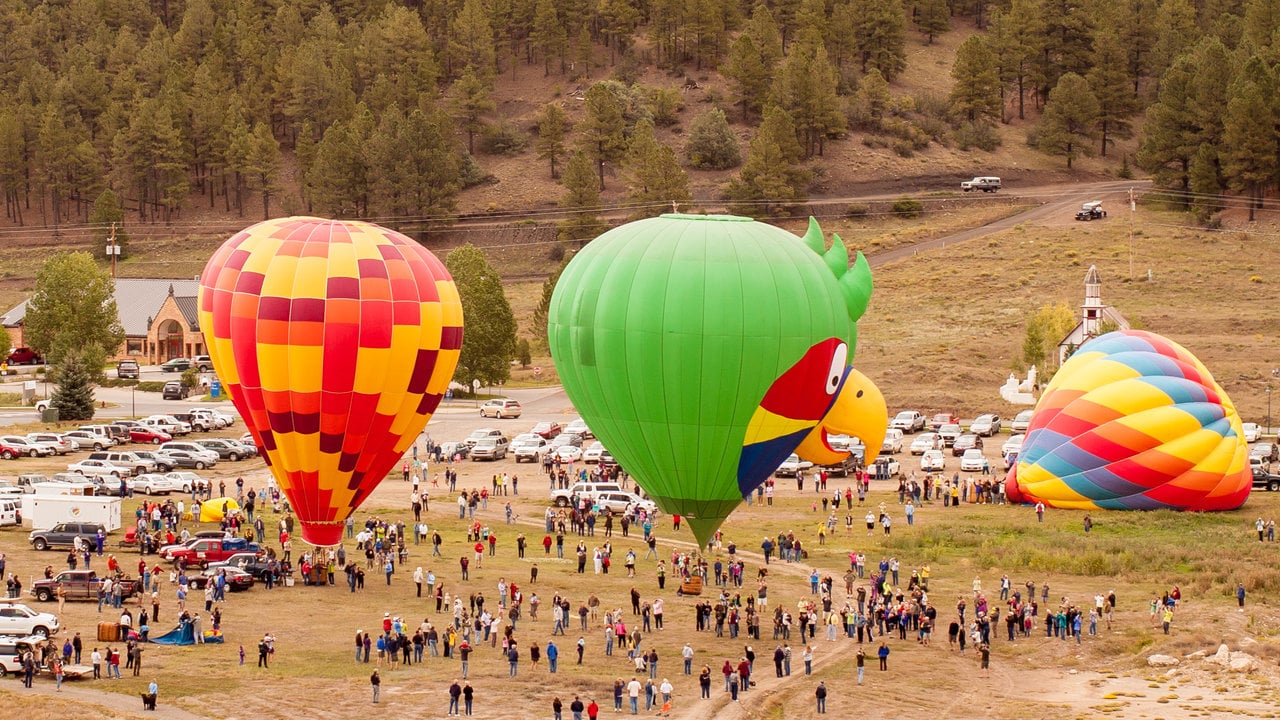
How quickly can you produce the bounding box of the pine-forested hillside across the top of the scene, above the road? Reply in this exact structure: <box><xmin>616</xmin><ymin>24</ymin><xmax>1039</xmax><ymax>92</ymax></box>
<box><xmin>0</xmin><ymin>0</ymin><xmax>1280</xmax><ymax>232</ymax></box>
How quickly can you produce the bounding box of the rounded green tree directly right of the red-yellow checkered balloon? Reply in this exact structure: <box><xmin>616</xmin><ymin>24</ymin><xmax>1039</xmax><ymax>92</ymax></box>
<box><xmin>444</xmin><ymin>243</ymin><xmax>516</xmax><ymax>386</ymax></box>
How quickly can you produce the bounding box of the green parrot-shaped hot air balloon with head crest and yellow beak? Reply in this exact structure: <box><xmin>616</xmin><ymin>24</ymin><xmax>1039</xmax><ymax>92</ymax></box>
<box><xmin>548</xmin><ymin>214</ymin><xmax>887</xmax><ymax>543</ymax></box>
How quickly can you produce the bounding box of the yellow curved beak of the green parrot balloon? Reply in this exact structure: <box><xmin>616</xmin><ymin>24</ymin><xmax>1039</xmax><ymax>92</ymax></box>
<box><xmin>796</xmin><ymin>368</ymin><xmax>888</xmax><ymax>465</ymax></box>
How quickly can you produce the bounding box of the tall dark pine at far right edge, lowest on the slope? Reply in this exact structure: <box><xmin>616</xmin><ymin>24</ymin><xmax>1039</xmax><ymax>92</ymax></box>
<box><xmin>1222</xmin><ymin>55</ymin><xmax>1280</xmax><ymax>222</ymax></box>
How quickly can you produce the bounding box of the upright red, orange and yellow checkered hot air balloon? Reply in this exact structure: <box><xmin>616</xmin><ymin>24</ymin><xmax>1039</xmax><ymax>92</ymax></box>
<box><xmin>200</xmin><ymin>218</ymin><xmax>462</xmax><ymax>546</ymax></box>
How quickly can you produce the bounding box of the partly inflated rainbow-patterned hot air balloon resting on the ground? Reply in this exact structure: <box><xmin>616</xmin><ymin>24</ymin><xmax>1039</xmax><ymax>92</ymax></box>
<box><xmin>1006</xmin><ymin>331</ymin><xmax>1252</xmax><ymax>510</ymax></box>
